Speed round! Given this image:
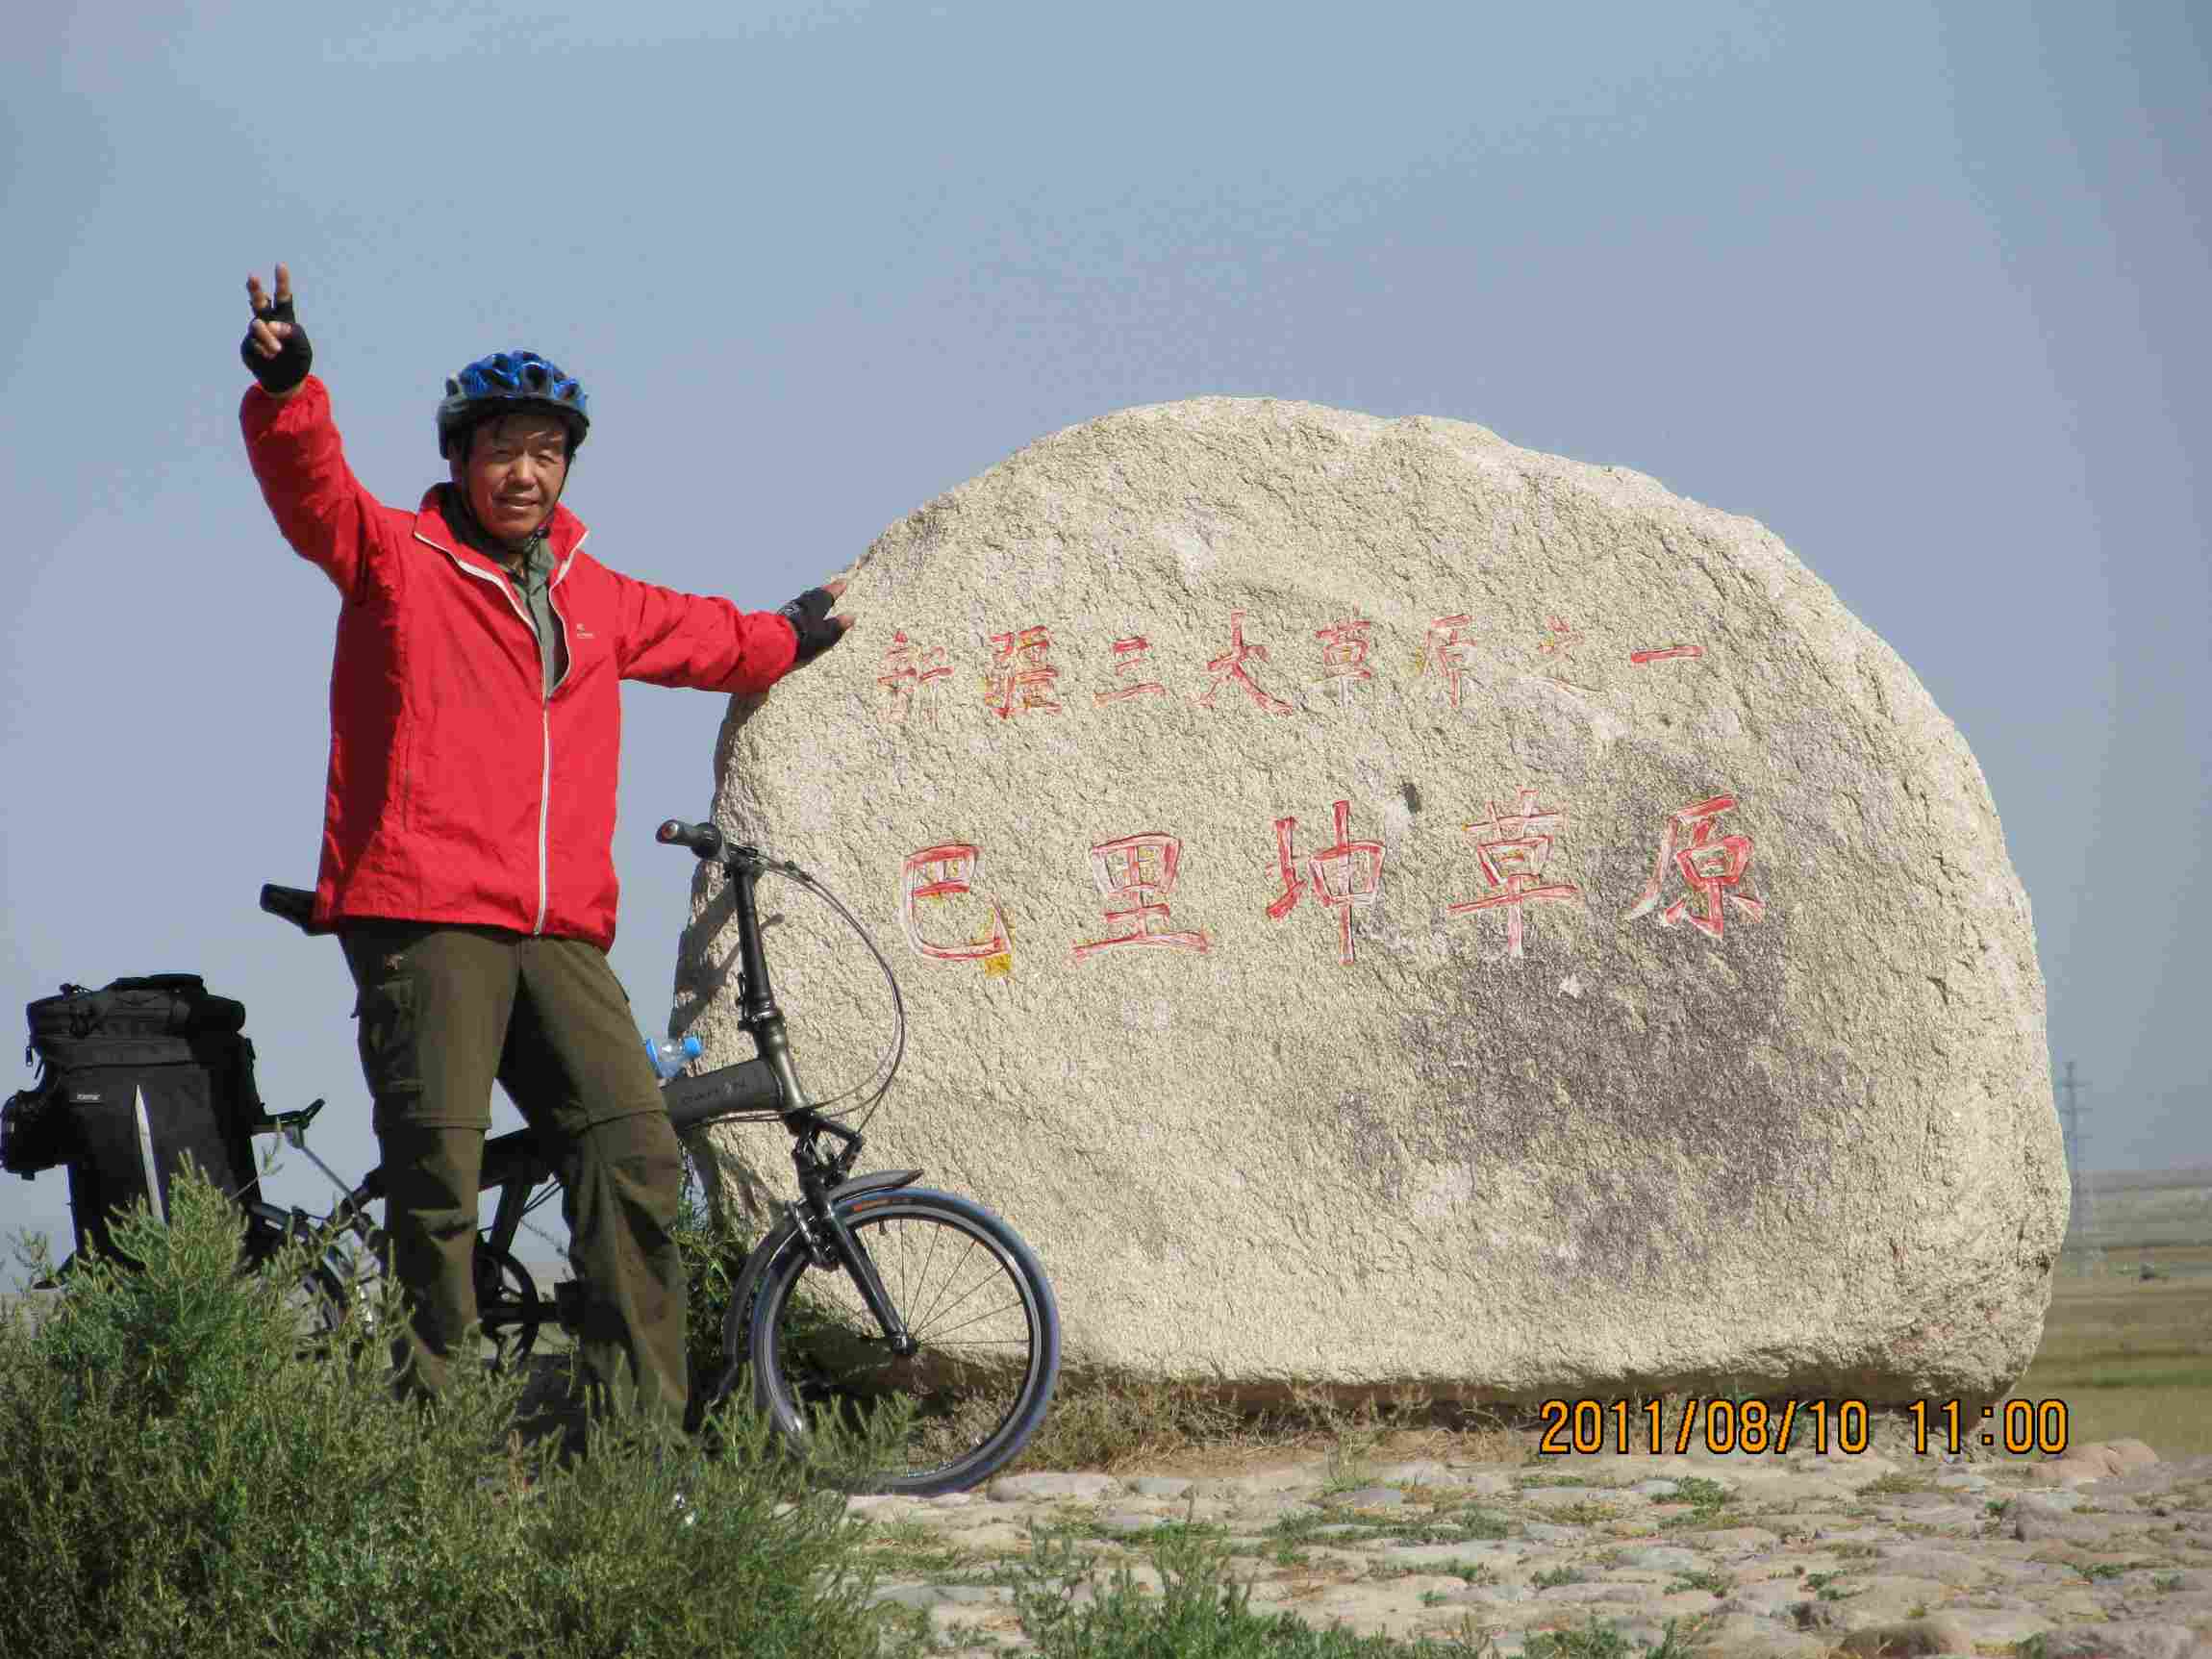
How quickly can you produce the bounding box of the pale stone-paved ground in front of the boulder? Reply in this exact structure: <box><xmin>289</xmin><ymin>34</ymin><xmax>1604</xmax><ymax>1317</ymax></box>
<box><xmin>852</xmin><ymin>1446</ymin><xmax>2212</xmax><ymax>1659</ymax></box>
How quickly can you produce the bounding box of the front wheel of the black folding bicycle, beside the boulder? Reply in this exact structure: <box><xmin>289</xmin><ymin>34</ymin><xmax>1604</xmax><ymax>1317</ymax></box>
<box><xmin>747</xmin><ymin>1188</ymin><xmax>1060</xmax><ymax>1497</ymax></box>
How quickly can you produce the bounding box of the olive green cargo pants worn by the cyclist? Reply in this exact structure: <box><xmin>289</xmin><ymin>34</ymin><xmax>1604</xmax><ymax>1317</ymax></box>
<box><xmin>343</xmin><ymin>920</ymin><xmax>688</xmax><ymax>1422</ymax></box>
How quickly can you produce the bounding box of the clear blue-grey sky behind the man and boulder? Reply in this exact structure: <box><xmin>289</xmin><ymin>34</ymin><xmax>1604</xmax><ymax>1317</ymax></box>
<box><xmin>0</xmin><ymin>0</ymin><xmax>2212</xmax><ymax>1265</ymax></box>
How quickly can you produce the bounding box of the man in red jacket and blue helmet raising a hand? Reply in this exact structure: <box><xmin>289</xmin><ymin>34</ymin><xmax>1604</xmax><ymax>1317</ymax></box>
<box><xmin>239</xmin><ymin>265</ymin><xmax>852</xmax><ymax>1420</ymax></box>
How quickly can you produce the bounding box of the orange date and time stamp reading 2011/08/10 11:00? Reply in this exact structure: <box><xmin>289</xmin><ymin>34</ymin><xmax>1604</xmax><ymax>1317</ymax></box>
<box><xmin>1538</xmin><ymin>1394</ymin><xmax>2066</xmax><ymax>1458</ymax></box>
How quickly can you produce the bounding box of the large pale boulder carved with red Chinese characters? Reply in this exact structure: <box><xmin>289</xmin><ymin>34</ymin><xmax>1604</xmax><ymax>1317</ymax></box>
<box><xmin>679</xmin><ymin>398</ymin><xmax>2066</xmax><ymax>1400</ymax></box>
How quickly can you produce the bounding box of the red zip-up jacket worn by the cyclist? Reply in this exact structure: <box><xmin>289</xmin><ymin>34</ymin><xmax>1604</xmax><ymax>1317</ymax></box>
<box><xmin>239</xmin><ymin>376</ymin><xmax>798</xmax><ymax>949</ymax></box>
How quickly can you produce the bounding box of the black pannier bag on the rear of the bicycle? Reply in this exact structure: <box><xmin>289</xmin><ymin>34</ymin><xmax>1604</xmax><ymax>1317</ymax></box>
<box><xmin>0</xmin><ymin>973</ymin><xmax>261</xmax><ymax>1252</ymax></box>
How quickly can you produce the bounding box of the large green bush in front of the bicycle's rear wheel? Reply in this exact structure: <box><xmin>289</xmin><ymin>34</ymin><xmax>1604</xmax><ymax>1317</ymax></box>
<box><xmin>0</xmin><ymin>1179</ymin><xmax>907</xmax><ymax>1659</ymax></box>
